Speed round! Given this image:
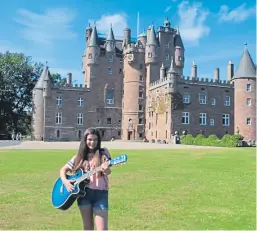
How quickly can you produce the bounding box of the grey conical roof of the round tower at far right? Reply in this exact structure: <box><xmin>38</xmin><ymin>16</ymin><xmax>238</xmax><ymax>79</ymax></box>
<box><xmin>233</xmin><ymin>44</ymin><xmax>256</xmax><ymax>79</ymax></box>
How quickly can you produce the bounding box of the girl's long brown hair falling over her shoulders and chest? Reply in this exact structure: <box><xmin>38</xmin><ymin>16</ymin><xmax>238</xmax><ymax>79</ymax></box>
<box><xmin>74</xmin><ymin>128</ymin><xmax>104</xmax><ymax>177</ymax></box>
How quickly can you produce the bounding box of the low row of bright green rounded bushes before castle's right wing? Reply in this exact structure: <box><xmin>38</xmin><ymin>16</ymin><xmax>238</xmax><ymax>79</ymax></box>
<box><xmin>180</xmin><ymin>134</ymin><xmax>243</xmax><ymax>147</ymax></box>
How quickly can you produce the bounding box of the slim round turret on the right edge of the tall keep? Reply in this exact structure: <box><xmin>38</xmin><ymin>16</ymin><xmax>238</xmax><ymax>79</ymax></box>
<box><xmin>174</xmin><ymin>29</ymin><xmax>185</xmax><ymax>75</ymax></box>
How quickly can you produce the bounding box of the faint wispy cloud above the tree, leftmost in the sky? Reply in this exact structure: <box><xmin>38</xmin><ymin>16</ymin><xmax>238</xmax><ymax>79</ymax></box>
<box><xmin>14</xmin><ymin>8</ymin><xmax>76</xmax><ymax>44</ymax></box>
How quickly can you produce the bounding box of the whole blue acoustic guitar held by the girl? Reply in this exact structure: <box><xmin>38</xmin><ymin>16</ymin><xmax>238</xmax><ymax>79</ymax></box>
<box><xmin>52</xmin><ymin>154</ymin><xmax>128</xmax><ymax>210</ymax></box>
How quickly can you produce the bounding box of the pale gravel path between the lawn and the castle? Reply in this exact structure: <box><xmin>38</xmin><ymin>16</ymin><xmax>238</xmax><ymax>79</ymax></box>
<box><xmin>0</xmin><ymin>140</ymin><xmax>217</xmax><ymax>150</ymax></box>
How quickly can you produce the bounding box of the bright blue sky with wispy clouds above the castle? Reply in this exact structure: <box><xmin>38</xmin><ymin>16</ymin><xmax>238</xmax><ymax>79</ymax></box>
<box><xmin>0</xmin><ymin>0</ymin><xmax>256</xmax><ymax>83</ymax></box>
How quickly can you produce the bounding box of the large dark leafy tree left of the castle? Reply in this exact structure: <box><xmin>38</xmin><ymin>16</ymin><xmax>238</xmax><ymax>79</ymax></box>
<box><xmin>0</xmin><ymin>52</ymin><xmax>43</xmax><ymax>134</ymax></box>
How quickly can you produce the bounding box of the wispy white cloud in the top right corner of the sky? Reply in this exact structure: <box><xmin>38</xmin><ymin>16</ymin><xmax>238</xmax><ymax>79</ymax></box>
<box><xmin>218</xmin><ymin>3</ymin><xmax>256</xmax><ymax>23</ymax></box>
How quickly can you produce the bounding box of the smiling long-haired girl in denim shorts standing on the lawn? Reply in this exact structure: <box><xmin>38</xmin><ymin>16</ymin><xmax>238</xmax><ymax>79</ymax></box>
<box><xmin>60</xmin><ymin>128</ymin><xmax>111</xmax><ymax>230</ymax></box>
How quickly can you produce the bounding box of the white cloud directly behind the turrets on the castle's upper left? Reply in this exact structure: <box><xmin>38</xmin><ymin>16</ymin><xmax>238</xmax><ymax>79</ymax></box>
<box><xmin>89</xmin><ymin>13</ymin><xmax>127</xmax><ymax>38</ymax></box>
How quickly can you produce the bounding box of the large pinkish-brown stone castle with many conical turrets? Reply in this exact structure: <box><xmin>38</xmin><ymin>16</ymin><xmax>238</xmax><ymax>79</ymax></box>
<box><xmin>32</xmin><ymin>20</ymin><xmax>256</xmax><ymax>142</ymax></box>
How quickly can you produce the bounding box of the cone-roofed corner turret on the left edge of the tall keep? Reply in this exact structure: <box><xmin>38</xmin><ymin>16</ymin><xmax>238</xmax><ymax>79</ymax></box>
<box><xmin>83</xmin><ymin>26</ymin><xmax>100</xmax><ymax>88</ymax></box>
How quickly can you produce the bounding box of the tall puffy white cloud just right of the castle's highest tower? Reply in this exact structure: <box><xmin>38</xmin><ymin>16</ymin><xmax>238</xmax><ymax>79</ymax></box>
<box><xmin>178</xmin><ymin>1</ymin><xmax>210</xmax><ymax>46</ymax></box>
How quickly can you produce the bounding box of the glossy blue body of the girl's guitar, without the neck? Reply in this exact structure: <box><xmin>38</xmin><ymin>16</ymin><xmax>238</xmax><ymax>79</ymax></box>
<box><xmin>52</xmin><ymin>170</ymin><xmax>88</xmax><ymax>210</ymax></box>
